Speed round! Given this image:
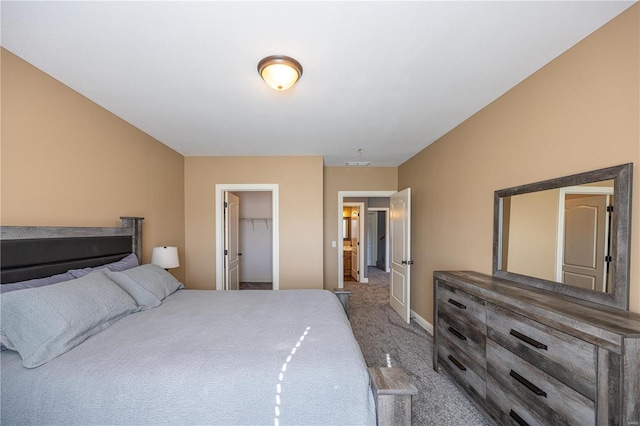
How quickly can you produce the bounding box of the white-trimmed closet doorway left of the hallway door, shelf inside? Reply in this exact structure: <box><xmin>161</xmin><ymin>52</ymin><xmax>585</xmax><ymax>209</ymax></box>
<box><xmin>215</xmin><ymin>184</ymin><xmax>280</xmax><ymax>290</ymax></box>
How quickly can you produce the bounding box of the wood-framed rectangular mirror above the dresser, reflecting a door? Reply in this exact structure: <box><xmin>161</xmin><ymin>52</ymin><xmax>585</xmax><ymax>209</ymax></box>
<box><xmin>493</xmin><ymin>163</ymin><xmax>633</xmax><ymax>310</ymax></box>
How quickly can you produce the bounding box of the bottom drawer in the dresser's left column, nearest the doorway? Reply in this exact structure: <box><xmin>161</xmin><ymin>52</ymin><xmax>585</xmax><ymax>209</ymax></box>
<box><xmin>438</xmin><ymin>336</ymin><xmax>486</xmax><ymax>399</ymax></box>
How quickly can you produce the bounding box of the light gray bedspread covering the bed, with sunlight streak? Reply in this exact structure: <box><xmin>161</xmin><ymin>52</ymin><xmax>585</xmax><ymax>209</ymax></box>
<box><xmin>1</xmin><ymin>290</ymin><xmax>375</xmax><ymax>426</ymax></box>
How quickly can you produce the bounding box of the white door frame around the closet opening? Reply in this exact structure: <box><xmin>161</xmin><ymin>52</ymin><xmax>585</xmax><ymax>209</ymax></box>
<box><xmin>215</xmin><ymin>183</ymin><xmax>278</xmax><ymax>290</ymax></box>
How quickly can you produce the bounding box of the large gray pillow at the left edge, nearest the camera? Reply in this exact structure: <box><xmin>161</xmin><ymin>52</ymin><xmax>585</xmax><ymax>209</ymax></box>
<box><xmin>0</xmin><ymin>271</ymin><xmax>138</xmax><ymax>368</ymax></box>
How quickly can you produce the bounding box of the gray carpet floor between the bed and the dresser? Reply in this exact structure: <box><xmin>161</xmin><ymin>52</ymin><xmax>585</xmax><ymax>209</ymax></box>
<box><xmin>345</xmin><ymin>267</ymin><xmax>489</xmax><ymax>426</ymax></box>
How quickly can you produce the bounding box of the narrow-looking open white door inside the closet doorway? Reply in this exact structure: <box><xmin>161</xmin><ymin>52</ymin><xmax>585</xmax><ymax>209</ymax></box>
<box><xmin>224</xmin><ymin>192</ymin><xmax>242</xmax><ymax>290</ymax></box>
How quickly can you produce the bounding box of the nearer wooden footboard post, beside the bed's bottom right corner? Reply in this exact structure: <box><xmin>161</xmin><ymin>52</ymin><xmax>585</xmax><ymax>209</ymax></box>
<box><xmin>369</xmin><ymin>367</ymin><xmax>418</xmax><ymax>426</ymax></box>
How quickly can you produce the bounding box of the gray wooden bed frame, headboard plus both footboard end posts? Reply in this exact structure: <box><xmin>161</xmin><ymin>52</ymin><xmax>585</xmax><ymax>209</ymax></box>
<box><xmin>0</xmin><ymin>217</ymin><xmax>418</xmax><ymax>426</ymax></box>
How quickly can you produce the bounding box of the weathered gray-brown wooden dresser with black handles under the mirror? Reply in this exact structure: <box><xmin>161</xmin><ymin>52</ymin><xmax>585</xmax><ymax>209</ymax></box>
<box><xmin>433</xmin><ymin>271</ymin><xmax>640</xmax><ymax>426</ymax></box>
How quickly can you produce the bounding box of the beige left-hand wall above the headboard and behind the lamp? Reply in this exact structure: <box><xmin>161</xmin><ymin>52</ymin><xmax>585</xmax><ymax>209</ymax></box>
<box><xmin>0</xmin><ymin>49</ymin><xmax>184</xmax><ymax>279</ymax></box>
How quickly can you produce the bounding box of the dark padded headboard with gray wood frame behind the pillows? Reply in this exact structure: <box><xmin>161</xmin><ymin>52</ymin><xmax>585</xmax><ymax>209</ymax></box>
<box><xmin>0</xmin><ymin>217</ymin><xmax>144</xmax><ymax>284</ymax></box>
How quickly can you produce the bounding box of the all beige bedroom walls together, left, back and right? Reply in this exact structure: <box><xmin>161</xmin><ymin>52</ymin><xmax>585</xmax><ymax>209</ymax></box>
<box><xmin>0</xmin><ymin>5</ymin><xmax>640</xmax><ymax>320</ymax></box>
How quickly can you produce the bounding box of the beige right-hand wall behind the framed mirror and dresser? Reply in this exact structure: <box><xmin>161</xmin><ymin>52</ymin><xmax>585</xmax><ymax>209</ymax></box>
<box><xmin>398</xmin><ymin>5</ymin><xmax>640</xmax><ymax>321</ymax></box>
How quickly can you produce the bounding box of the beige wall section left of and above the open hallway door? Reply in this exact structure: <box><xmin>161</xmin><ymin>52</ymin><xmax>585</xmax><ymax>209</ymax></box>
<box><xmin>324</xmin><ymin>167</ymin><xmax>398</xmax><ymax>290</ymax></box>
